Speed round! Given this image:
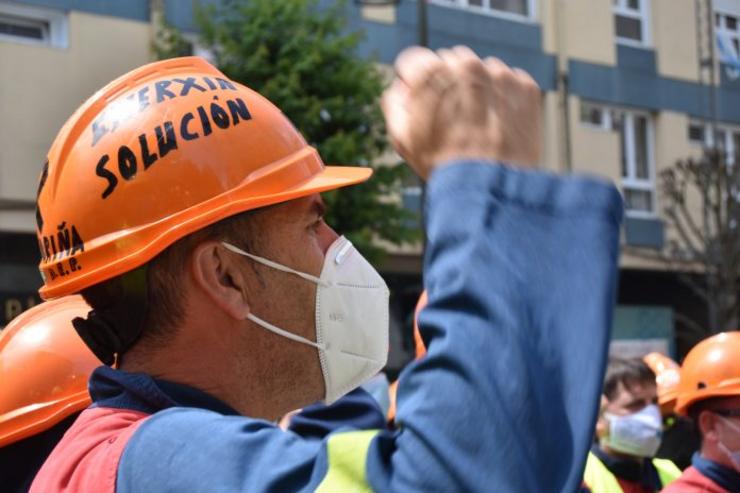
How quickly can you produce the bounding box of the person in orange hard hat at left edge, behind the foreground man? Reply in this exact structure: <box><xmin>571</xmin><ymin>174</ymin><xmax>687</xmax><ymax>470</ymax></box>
<box><xmin>0</xmin><ymin>296</ymin><xmax>101</xmax><ymax>492</ymax></box>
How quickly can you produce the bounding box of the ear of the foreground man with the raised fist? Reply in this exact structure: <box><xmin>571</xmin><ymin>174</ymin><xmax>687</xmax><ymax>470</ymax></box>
<box><xmin>189</xmin><ymin>241</ymin><xmax>249</xmax><ymax>320</ymax></box>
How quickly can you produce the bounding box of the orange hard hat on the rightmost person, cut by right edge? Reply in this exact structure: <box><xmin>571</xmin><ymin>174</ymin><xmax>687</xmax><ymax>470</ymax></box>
<box><xmin>676</xmin><ymin>331</ymin><xmax>740</xmax><ymax>416</ymax></box>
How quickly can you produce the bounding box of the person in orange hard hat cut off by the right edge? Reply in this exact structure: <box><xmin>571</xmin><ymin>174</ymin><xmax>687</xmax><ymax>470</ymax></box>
<box><xmin>665</xmin><ymin>332</ymin><xmax>740</xmax><ymax>493</ymax></box>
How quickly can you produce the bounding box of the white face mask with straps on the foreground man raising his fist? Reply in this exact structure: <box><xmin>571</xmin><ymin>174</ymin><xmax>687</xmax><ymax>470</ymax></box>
<box><xmin>223</xmin><ymin>236</ymin><xmax>390</xmax><ymax>404</ymax></box>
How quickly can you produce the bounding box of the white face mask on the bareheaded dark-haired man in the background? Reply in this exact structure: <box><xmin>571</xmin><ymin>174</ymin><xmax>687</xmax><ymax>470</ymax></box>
<box><xmin>601</xmin><ymin>404</ymin><xmax>663</xmax><ymax>457</ymax></box>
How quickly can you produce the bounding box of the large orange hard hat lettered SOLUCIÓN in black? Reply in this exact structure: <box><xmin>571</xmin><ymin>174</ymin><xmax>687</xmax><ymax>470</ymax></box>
<box><xmin>36</xmin><ymin>57</ymin><xmax>372</xmax><ymax>299</ymax></box>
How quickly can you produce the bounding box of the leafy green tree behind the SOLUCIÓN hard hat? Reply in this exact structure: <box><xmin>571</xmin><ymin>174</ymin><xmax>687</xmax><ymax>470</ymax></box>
<box><xmin>155</xmin><ymin>0</ymin><xmax>419</xmax><ymax>260</ymax></box>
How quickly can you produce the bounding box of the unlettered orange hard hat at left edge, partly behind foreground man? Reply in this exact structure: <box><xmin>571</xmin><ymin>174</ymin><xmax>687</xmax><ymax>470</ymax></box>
<box><xmin>0</xmin><ymin>296</ymin><xmax>101</xmax><ymax>447</ymax></box>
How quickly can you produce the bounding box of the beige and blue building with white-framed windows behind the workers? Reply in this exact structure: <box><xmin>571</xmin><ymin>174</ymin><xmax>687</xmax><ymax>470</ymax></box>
<box><xmin>0</xmin><ymin>0</ymin><xmax>740</xmax><ymax>364</ymax></box>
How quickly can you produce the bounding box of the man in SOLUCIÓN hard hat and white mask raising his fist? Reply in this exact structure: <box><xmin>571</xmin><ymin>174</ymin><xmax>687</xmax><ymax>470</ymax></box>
<box><xmin>32</xmin><ymin>47</ymin><xmax>622</xmax><ymax>493</ymax></box>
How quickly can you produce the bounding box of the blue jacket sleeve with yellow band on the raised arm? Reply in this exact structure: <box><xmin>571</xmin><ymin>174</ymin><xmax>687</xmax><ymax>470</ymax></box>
<box><xmin>117</xmin><ymin>162</ymin><xmax>622</xmax><ymax>492</ymax></box>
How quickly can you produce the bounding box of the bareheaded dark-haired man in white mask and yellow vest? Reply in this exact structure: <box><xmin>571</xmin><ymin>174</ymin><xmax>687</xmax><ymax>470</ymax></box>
<box><xmin>583</xmin><ymin>358</ymin><xmax>681</xmax><ymax>493</ymax></box>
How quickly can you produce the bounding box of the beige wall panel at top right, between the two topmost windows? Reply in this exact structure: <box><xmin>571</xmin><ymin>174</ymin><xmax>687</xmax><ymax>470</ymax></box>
<box><xmin>651</xmin><ymin>0</ymin><xmax>699</xmax><ymax>81</ymax></box>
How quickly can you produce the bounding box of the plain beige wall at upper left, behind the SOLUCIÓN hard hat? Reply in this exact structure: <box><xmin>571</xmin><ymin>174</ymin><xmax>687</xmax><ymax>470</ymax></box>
<box><xmin>0</xmin><ymin>11</ymin><xmax>150</xmax><ymax>231</ymax></box>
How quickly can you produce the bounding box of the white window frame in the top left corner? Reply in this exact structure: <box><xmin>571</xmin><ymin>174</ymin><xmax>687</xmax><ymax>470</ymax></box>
<box><xmin>0</xmin><ymin>2</ymin><xmax>69</xmax><ymax>49</ymax></box>
